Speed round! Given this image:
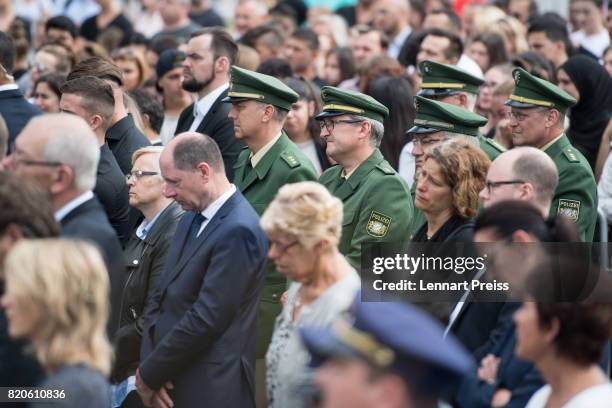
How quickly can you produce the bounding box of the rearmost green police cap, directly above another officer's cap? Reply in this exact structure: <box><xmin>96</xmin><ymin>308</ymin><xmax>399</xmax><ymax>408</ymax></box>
<box><xmin>418</xmin><ymin>61</ymin><xmax>484</xmax><ymax>96</ymax></box>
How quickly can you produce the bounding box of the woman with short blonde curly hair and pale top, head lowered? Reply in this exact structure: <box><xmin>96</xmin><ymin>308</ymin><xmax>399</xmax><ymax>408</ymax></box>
<box><xmin>261</xmin><ymin>181</ymin><xmax>360</xmax><ymax>407</ymax></box>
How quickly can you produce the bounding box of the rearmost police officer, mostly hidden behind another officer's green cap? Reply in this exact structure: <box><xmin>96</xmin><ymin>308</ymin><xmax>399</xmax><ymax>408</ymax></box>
<box><xmin>418</xmin><ymin>60</ymin><xmax>506</xmax><ymax>161</ymax></box>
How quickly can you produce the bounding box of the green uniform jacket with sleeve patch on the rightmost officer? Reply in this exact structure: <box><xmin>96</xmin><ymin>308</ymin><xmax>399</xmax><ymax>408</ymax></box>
<box><xmin>544</xmin><ymin>134</ymin><xmax>597</xmax><ymax>242</ymax></box>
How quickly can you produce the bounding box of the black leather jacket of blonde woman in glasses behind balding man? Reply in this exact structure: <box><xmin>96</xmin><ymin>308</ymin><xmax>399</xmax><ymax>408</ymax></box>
<box><xmin>111</xmin><ymin>202</ymin><xmax>183</xmax><ymax>383</ymax></box>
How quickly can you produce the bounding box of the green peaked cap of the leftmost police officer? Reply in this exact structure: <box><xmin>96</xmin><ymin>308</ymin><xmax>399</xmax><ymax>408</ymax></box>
<box><xmin>223</xmin><ymin>65</ymin><xmax>299</xmax><ymax>111</ymax></box>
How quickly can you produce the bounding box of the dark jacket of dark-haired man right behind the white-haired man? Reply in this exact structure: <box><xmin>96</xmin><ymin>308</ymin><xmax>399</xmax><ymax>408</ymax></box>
<box><xmin>93</xmin><ymin>144</ymin><xmax>131</xmax><ymax>245</ymax></box>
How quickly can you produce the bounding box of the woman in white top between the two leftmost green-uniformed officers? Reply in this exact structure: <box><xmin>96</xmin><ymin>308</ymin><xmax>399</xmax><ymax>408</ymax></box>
<box><xmin>283</xmin><ymin>77</ymin><xmax>329</xmax><ymax>175</ymax></box>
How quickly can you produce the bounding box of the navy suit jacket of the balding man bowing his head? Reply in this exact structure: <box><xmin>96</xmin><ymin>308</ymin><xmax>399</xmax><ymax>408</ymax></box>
<box><xmin>140</xmin><ymin>191</ymin><xmax>268</xmax><ymax>408</ymax></box>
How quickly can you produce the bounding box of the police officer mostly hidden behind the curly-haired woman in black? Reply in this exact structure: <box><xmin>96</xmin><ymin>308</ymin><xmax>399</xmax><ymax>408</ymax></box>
<box><xmin>406</xmin><ymin>96</ymin><xmax>487</xmax><ymax>237</ymax></box>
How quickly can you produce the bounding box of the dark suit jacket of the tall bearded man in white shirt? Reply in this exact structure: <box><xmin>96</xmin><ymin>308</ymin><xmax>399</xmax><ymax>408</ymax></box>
<box><xmin>174</xmin><ymin>90</ymin><xmax>244</xmax><ymax>180</ymax></box>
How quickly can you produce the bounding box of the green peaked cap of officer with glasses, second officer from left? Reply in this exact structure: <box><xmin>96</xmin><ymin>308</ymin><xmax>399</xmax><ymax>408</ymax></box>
<box><xmin>315</xmin><ymin>86</ymin><xmax>389</xmax><ymax>123</ymax></box>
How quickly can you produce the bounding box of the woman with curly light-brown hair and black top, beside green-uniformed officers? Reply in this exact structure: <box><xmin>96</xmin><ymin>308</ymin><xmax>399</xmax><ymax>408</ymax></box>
<box><xmin>412</xmin><ymin>137</ymin><xmax>491</xmax><ymax>242</ymax></box>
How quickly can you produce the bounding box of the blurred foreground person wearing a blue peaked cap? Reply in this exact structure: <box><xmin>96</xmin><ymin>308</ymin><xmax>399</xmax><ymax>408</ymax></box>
<box><xmin>300</xmin><ymin>301</ymin><xmax>473</xmax><ymax>408</ymax></box>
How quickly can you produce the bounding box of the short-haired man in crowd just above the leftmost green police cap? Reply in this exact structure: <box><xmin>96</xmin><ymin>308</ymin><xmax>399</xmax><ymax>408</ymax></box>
<box><xmin>283</xmin><ymin>28</ymin><xmax>325</xmax><ymax>87</ymax></box>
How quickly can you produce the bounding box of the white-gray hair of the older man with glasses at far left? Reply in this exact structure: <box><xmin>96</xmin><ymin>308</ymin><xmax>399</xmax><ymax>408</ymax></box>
<box><xmin>38</xmin><ymin>113</ymin><xmax>100</xmax><ymax>193</ymax></box>
